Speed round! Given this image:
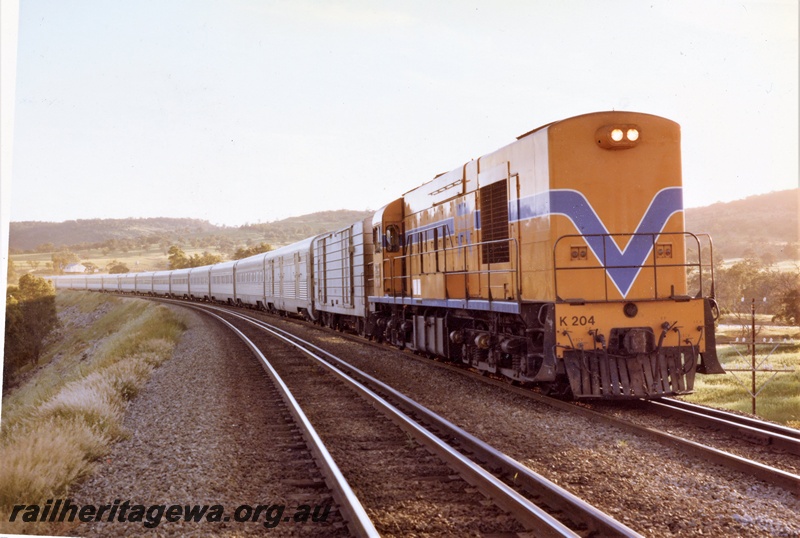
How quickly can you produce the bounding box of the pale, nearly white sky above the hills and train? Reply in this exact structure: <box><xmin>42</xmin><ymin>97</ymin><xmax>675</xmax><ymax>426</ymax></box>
<box><xmin>3</xmin><ymin>0</ymin><xmax>798</xmax><ymax>225</ymax></box>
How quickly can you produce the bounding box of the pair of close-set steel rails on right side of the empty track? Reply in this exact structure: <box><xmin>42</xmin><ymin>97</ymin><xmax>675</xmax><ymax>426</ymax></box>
<box><xmin>212</xmin><ymin>307</ymin><xmax>641</xmax><ymax>537</ymax></box>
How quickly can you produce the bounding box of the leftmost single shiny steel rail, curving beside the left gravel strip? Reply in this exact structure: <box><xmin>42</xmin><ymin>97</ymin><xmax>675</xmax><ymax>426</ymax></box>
<box><xmin>178</xmin><ymin>300</ymin><xmax>380</xmax><ymax>538</ymax></box>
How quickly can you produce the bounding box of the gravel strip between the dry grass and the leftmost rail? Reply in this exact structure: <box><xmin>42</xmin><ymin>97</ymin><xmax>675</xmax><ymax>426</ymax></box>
<box><xmin>67</xmin><ymin>309</ymin><xmax>348</xmax><ymax>536</ymax></box>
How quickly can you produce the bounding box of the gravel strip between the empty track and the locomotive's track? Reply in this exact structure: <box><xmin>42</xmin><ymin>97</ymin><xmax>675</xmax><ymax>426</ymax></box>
<box><xmin>270</xmin><ymin>318</ymin><xmax>800</xmax><ymax>537</ymax></box>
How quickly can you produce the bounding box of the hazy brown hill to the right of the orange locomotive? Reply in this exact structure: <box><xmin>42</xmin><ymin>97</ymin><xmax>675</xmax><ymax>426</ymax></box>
<box><xmin>686</xmin><ymin>189</ymin><xmax>800</xmax><ymax>261</ymax></box>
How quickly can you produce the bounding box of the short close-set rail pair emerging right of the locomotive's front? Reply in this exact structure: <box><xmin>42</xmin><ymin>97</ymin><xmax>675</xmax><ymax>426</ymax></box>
<box><xmin>647</xmin><ymin>398</ymin><xmax>800</xmax><ymax>455</ymax></box>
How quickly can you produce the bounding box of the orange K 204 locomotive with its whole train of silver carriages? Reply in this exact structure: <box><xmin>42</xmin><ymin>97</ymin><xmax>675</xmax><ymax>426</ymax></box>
<box><xmin>54</xmin><ymin>112</ymin><xmax>723</xmax><ymax>398</ymax></box>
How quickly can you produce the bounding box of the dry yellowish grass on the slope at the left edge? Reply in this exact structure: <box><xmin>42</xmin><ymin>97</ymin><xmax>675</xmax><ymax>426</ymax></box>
<box><xmin>0</xmin><ymin>293</ymin><xmax>186</xmax><ymax>532</ymax></box>
